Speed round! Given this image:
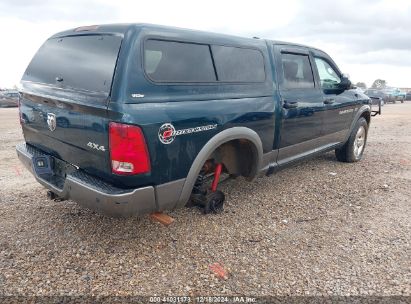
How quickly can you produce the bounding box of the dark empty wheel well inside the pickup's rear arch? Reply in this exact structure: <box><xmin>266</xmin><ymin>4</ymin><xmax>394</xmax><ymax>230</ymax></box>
<box><xmin>209</xmin><ymin>139</ymin><xmax>258</xmax><ymax>179</ymax></box>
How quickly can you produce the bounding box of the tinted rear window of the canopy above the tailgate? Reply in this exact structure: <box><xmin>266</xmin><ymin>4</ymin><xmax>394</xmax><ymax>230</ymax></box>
<box><xmin>22</xmin><ymin>35</ymin><xmax>122</xmax><ymax>95</ymax></box>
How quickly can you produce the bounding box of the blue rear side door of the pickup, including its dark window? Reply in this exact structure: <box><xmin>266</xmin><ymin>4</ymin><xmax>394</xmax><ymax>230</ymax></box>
<box><xmin>275</xmin><ymin>45</ymin><xmax>324</xmax><ymax>164</ymax></box>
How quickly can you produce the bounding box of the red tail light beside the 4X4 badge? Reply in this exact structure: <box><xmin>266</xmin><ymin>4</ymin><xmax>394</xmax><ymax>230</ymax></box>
<box><xmin>109</xmin><ymin>122</ymin><xmax>151</xmax><ymax>175</ymax></box>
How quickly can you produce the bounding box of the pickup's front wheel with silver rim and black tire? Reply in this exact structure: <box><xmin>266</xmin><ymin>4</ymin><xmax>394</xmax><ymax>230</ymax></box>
<box><xmin>335</xmin><ymin>117</ymin><xmax>368</xmax><ymax>163</ymax></box>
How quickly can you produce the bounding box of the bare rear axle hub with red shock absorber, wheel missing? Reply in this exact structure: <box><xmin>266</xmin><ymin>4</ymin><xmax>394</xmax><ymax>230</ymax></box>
<box><xmin>191</xmin><ymin>163</ymin><xmax>225</xmax><ymax>214</ymax></box>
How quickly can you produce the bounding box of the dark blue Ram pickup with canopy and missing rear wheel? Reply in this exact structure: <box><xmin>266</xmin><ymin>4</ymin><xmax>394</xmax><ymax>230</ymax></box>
<box><xmin>16</xmin><ymin>24</ymin><xmax>371</xmax><ymax>216</ymax></box>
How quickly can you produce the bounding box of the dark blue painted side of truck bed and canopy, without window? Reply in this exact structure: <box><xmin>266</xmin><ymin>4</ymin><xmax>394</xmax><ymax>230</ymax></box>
<box><xmin>109</xmin><ymin>29</ymin><xmax>277</xmax><ymax>186</ymax></box>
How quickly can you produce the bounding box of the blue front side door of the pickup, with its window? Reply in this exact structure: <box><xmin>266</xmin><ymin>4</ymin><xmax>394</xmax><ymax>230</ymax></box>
<box><xmin>313</xmin><ymin>50</ymin><xmax>358</xmax><ymax>144</ymax></box>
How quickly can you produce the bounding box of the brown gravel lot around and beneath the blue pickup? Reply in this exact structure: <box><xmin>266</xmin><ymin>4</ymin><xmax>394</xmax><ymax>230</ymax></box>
<box><xmin>0</xmin><ymin>102</ymin><xmax>411</xmax><ymax>296</ymax></box>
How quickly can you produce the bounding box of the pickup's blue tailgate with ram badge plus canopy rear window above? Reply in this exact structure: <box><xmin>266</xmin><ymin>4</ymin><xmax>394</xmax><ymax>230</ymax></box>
<box><xmin>20</xmin><ymin>34</ymin><xmax>122</xmax><ymax>174</ymax></box>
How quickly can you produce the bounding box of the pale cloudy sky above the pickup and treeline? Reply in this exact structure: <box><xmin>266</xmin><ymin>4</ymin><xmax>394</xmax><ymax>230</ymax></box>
<box><xmin>0</xmin><ymin>0</ymin><xmax>411</xmax><ymax>88</ymax></box>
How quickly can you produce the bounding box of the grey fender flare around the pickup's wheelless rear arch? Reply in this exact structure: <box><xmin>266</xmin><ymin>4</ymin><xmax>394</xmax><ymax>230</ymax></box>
<box><xmin>176</xmin><ymin>127</ymin><xmax>263</xmax><ymax>208</ymax></box>
